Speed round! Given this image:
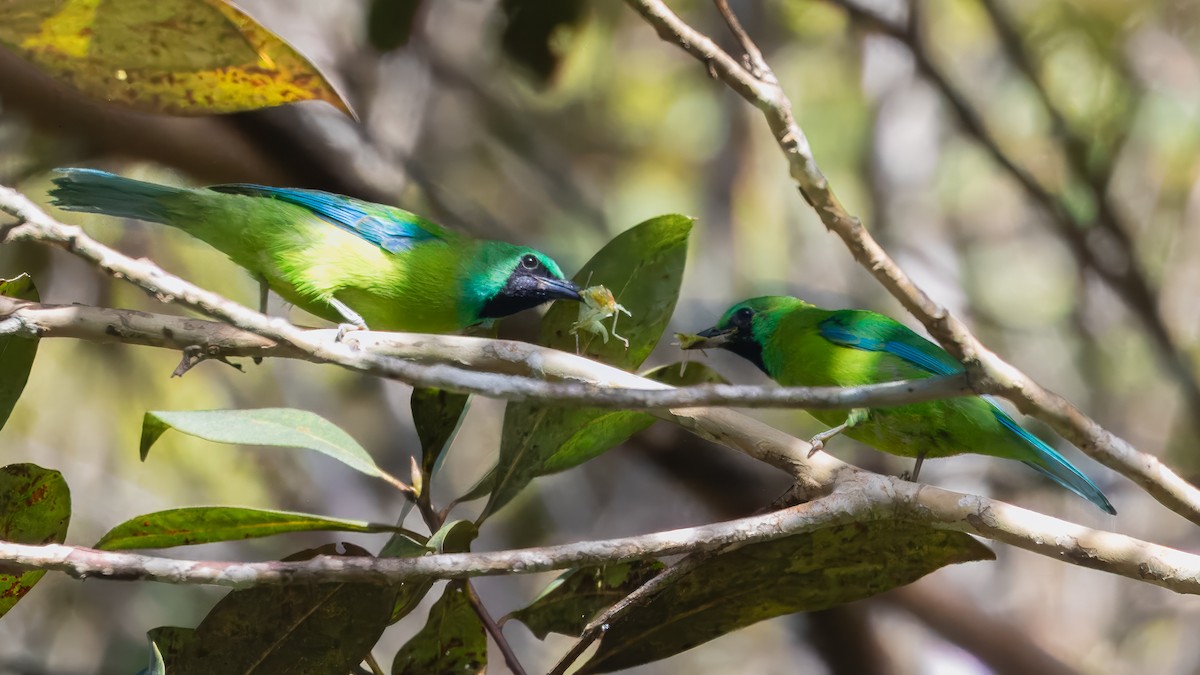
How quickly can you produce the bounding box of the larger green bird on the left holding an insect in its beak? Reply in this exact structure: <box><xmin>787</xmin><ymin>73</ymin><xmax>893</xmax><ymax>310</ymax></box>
<box><xmin>50</xmin><ymin>168</ymin><xmax>580</xmax><ymax>336</ymax></box>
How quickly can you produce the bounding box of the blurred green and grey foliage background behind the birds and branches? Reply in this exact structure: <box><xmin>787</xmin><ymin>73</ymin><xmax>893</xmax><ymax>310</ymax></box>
<box><xmin>0</xmin><ymin>0</ymin><xmax>1200</xmax><ymax>674</ymax></box>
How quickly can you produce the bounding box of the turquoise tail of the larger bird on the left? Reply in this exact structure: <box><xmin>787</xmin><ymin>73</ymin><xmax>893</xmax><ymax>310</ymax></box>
<box><xmin>50</xmin><ymin>168</ymin><xmax>186</xmax><ymax>223</ymax></box>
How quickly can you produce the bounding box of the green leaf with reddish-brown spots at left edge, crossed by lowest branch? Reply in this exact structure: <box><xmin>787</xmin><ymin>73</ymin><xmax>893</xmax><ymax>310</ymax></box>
<box><xmin>0</xmin><ymin>464</ymin><xmax>71</xmax><ymax>616</ymax></box>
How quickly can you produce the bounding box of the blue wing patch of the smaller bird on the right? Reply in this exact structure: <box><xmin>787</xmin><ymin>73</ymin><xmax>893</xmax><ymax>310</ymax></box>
<box><xmin>818</xmin><ymin>311</ymin><xmax>962</xmax><ymax>375</ymax></box>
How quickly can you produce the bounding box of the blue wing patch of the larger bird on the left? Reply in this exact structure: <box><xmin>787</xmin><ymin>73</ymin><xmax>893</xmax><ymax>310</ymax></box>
<box><xmin>209</xmin><ymin>184</ymin><xmax>442</xmax><ymax>253</ymax></box>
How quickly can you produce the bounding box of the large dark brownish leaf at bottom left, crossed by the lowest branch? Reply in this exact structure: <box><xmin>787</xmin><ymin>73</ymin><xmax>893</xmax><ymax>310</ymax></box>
<box><xmin>159</xmin><ymin>543</ymin><xmax>394</xmax><ymax>675</ymax></box>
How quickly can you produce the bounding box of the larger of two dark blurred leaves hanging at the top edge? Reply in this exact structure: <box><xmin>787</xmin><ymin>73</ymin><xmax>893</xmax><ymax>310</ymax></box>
<box><xmin>500</xmin><ymin>0</ymin><xmax>584</xmax><ymax>84</ymax></box>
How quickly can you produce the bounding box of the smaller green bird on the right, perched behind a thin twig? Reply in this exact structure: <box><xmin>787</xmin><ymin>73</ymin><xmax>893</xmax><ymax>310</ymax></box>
<box><xmin>685</xmin><ymin>295</ymin><xmax>1116</xmax><ymax>514</ymax></box>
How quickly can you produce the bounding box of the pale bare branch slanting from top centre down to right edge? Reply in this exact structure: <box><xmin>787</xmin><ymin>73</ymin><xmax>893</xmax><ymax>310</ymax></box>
<box><xmin>626</xmin><ymin>0</ymin><xmax>1200</xmax><ymax>524</ymax></box>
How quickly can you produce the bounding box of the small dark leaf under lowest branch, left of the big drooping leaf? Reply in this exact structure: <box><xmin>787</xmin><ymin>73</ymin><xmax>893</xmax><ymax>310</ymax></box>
<box><xmin>500</xmin><ymin>560</ymin><xmax>666</xmax><ymax>640</ymax></box>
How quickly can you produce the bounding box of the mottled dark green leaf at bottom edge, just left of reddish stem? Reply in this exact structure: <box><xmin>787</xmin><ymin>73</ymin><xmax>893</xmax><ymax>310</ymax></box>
<box><xmin>391</xmin><ymin>581</ymin><xmax>487</xmax><ymax>675</ymax></box>
